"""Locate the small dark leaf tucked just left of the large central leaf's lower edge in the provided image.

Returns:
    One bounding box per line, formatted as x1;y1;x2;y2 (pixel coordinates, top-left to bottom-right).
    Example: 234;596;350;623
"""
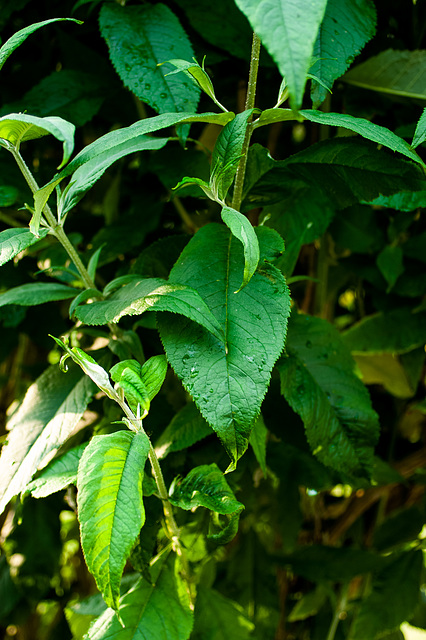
155;402;213;460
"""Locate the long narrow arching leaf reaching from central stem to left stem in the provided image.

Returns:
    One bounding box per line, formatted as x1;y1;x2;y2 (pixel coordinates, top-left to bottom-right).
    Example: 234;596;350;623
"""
34;113;234;220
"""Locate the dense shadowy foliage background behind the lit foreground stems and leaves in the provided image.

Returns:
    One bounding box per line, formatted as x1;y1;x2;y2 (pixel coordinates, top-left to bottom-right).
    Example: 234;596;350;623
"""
0;0;426;640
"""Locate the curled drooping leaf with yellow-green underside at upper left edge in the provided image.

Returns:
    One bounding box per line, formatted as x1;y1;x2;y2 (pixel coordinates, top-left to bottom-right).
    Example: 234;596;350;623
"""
0;113;75;169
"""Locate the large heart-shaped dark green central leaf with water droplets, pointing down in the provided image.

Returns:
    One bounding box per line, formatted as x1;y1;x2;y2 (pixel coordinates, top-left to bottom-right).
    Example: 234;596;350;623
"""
158;224;290;464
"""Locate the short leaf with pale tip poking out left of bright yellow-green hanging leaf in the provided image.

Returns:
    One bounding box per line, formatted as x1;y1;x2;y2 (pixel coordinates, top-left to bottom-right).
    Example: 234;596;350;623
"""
25;442;87;498
